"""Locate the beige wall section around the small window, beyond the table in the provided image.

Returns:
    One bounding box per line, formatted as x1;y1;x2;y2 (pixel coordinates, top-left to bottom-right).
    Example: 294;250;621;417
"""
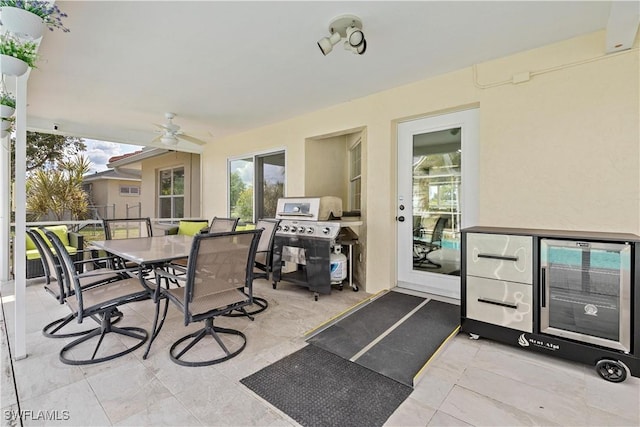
141;152;200;218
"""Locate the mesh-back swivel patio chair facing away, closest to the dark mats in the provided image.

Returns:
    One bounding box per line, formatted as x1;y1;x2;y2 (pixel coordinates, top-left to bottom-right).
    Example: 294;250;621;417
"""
143;230;262;366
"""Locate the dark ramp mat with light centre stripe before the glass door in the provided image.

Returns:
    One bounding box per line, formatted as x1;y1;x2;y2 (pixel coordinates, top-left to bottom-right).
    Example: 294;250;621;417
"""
308;292;460;387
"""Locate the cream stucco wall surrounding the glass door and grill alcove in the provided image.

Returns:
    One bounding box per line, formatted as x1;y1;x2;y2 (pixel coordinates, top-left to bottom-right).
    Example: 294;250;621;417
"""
202;32;640;292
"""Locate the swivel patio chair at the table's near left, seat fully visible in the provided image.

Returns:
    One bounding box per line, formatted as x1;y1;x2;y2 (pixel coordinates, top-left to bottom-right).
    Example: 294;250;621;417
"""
46;231;151;365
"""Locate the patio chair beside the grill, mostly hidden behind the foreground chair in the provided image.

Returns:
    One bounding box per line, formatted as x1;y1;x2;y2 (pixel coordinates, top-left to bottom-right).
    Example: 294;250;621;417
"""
227;218;280;318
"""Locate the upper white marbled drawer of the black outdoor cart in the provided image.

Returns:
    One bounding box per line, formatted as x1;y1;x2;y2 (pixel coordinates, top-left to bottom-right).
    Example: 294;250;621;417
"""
466;233;533;283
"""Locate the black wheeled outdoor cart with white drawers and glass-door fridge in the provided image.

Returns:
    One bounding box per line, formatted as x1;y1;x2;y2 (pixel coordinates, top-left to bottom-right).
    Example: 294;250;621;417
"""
461;227;640;382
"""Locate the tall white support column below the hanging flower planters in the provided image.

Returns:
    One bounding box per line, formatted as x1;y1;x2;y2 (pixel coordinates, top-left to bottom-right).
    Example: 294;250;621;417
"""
13;73;28;360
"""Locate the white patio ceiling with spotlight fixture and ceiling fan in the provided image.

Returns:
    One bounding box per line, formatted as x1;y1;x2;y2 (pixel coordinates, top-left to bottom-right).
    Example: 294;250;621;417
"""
10;1;636;151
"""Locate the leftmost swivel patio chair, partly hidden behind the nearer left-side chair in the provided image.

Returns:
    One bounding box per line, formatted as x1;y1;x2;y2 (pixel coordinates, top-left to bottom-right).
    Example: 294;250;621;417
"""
27;229;126;338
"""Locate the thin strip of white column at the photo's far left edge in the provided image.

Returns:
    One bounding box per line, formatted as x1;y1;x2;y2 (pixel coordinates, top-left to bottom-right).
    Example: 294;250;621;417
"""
0;123;11;284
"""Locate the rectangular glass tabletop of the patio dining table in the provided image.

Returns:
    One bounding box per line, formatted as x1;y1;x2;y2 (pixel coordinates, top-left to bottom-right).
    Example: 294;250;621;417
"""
91;235;193;265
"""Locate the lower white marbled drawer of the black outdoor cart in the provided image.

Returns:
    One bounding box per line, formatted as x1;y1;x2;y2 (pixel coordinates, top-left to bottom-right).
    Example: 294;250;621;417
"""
466;276;533;332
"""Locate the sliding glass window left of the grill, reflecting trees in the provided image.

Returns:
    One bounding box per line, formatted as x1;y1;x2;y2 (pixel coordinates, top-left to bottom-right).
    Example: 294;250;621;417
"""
229;151;285;222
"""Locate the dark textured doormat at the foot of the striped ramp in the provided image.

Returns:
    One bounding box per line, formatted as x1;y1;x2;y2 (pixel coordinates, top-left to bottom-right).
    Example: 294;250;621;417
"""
240;345;412;427
